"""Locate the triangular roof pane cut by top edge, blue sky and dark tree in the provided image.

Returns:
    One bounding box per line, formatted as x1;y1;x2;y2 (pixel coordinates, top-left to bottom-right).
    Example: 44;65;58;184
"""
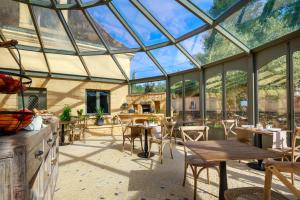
191;0;238;19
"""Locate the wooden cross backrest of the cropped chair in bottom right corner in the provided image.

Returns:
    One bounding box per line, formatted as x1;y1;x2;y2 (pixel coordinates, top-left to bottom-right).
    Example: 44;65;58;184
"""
264;161;300;200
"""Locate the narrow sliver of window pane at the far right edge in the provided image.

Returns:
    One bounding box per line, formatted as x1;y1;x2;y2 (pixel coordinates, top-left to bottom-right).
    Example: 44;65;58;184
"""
293;51;300;127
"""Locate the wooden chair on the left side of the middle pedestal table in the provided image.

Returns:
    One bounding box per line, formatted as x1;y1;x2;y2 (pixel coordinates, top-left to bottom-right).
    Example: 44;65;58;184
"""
118;118;143;155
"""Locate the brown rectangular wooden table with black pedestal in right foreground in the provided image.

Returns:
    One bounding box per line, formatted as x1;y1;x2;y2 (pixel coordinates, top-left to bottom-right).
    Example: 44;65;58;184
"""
185;140;278;199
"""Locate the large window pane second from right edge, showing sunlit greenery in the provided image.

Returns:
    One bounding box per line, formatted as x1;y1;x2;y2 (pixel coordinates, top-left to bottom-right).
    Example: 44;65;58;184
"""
258;56;287;129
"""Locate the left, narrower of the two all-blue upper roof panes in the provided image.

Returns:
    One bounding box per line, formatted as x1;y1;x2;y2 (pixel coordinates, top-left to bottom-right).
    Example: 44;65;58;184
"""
112;0;168;46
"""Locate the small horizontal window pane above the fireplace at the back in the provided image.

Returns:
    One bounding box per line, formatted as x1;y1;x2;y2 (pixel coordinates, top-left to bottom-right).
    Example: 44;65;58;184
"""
131;81;166;93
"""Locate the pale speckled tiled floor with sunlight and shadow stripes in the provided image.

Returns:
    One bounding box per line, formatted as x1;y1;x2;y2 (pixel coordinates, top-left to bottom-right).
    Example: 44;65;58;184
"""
55;136;300;200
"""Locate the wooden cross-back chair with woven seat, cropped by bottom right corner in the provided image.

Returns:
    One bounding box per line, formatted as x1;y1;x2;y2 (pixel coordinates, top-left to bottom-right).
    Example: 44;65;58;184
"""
224;161;300;200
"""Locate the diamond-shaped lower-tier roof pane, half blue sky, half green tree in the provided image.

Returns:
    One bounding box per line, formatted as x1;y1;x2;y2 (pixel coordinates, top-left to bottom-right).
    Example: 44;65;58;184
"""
180;29;242;64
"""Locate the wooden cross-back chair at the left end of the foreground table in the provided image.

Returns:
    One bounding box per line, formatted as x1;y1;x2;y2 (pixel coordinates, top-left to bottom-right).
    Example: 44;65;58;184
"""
180;126;219;200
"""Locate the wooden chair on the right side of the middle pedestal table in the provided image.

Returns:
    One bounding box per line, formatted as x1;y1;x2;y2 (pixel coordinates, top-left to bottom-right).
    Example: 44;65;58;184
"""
149;120;175;164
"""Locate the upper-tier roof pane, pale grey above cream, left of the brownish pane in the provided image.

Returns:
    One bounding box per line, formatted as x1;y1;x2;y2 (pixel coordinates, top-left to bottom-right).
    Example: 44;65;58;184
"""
32;6;74;51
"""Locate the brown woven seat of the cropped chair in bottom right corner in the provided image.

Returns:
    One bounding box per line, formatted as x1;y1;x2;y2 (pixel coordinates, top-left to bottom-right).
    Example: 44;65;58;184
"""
224;187;288;200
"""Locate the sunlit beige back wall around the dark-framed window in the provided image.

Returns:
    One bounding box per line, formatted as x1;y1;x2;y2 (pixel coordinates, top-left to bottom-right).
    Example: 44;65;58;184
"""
0;78;128;115
